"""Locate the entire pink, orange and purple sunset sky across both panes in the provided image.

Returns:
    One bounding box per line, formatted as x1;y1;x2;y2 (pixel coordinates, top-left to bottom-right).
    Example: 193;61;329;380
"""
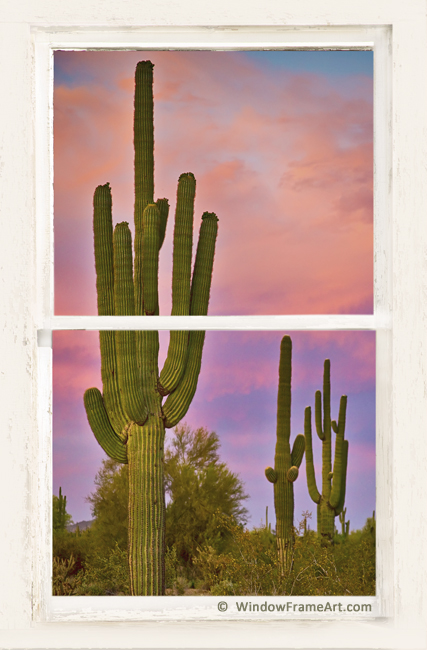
53;51;375;528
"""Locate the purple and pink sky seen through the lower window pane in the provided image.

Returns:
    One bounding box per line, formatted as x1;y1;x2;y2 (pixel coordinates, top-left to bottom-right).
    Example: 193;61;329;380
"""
53;332;375;527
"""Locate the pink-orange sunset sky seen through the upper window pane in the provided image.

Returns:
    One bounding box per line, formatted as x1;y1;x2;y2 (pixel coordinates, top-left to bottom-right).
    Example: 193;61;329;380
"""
54;51;373;315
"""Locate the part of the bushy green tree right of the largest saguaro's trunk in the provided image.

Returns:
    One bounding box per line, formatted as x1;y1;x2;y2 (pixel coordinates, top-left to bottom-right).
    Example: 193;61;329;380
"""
165;424;248;565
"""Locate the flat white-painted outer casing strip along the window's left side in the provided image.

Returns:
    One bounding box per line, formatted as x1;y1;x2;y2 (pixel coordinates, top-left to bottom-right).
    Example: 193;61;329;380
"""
0;23;36;632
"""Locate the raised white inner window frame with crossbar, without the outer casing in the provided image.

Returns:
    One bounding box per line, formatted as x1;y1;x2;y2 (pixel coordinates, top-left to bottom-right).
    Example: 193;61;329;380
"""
34;27;394;626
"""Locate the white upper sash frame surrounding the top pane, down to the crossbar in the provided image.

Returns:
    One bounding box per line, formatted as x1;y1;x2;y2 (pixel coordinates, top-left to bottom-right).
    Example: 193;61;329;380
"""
36;27;392;330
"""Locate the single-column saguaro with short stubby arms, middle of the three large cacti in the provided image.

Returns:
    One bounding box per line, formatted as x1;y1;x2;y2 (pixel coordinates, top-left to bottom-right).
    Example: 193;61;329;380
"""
265;336;305;573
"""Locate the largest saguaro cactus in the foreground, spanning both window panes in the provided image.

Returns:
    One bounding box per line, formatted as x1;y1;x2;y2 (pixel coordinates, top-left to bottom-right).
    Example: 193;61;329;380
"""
84;61;218;595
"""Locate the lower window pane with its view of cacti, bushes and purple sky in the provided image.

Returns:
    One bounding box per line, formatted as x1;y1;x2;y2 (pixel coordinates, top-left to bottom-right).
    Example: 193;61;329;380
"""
53;331;375;595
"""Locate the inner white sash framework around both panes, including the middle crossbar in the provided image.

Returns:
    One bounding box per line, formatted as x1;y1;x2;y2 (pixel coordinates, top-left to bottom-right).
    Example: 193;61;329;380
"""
36;21;393;621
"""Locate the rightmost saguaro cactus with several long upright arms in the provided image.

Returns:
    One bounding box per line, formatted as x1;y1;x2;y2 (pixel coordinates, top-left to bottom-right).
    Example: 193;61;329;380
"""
304;359;348;546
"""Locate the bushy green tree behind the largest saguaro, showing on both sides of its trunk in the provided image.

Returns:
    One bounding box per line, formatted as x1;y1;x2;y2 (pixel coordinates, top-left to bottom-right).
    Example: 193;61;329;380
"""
87;425;248;564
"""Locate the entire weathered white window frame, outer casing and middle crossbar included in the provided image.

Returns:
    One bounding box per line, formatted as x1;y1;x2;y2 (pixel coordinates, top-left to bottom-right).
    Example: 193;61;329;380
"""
0;5;427;648
